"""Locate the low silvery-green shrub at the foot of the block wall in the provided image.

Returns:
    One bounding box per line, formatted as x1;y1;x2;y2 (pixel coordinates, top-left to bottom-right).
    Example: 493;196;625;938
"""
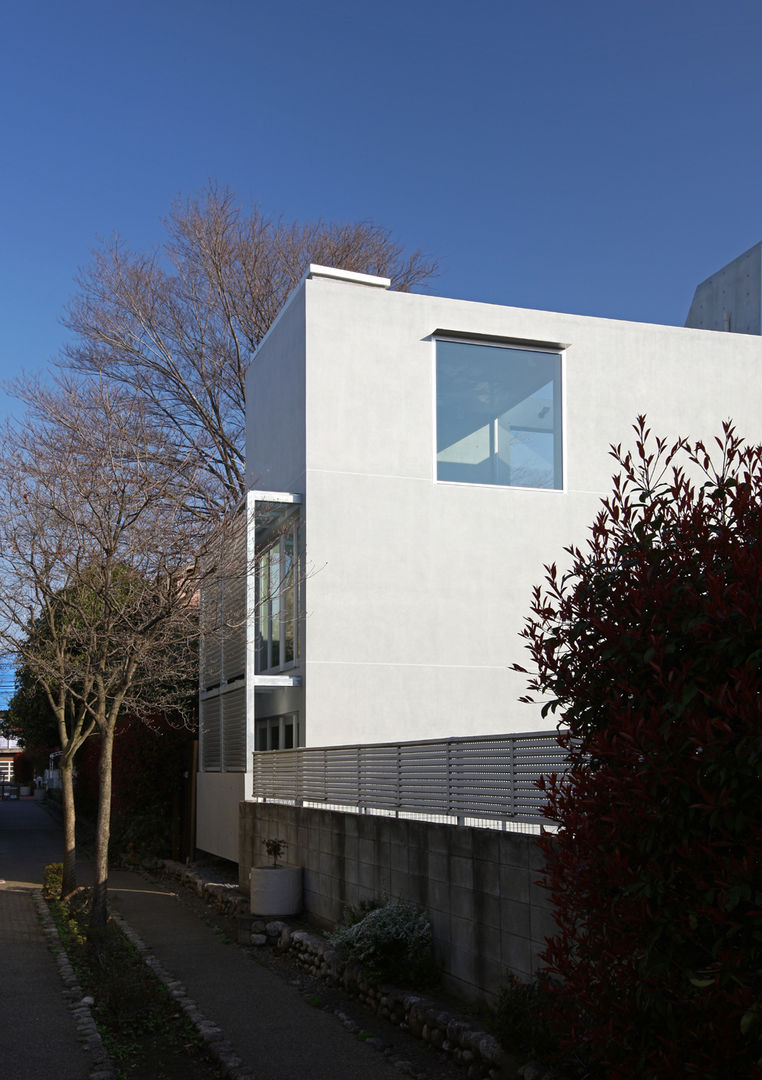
328;901;436;986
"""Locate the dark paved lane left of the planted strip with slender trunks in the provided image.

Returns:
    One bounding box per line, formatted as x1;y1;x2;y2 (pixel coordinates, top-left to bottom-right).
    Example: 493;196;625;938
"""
0;799;95;1080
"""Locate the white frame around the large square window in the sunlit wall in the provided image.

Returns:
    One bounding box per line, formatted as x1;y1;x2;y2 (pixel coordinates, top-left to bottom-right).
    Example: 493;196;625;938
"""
432;329;569;494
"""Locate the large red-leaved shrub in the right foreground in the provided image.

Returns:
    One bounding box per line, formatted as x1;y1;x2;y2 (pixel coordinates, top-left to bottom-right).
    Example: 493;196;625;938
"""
518;417;762;1080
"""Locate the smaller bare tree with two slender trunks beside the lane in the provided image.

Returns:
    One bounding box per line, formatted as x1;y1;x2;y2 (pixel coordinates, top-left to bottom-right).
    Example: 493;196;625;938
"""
0;380;205;924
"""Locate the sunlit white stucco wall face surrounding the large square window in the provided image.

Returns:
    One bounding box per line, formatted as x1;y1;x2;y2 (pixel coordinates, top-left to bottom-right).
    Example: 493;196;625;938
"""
293;272;762;745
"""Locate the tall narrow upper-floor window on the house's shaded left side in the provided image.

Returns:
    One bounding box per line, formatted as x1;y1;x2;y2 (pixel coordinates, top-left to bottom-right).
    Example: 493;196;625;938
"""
256;524;299;675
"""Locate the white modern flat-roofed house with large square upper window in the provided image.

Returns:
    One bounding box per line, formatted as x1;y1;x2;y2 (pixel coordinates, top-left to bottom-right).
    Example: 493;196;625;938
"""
198;245;762;860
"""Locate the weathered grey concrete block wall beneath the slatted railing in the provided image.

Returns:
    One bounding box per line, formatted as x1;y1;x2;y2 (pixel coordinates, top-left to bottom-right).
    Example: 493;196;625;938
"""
240;802;555;998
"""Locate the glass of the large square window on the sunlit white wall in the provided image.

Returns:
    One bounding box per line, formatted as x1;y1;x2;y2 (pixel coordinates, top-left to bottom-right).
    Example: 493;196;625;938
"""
436;340;562;488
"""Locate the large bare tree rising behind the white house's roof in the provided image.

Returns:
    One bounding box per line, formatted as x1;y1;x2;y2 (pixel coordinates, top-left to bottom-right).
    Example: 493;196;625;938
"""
65;186;436;518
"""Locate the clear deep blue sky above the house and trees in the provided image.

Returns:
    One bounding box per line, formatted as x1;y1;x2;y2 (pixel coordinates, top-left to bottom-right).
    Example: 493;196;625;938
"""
0;0;762;704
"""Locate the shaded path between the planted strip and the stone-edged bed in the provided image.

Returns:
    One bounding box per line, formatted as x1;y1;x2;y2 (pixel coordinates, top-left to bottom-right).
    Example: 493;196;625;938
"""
103;870;442;1080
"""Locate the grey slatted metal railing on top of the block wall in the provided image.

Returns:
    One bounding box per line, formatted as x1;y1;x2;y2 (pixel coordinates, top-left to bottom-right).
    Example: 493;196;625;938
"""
251;731;566;828
